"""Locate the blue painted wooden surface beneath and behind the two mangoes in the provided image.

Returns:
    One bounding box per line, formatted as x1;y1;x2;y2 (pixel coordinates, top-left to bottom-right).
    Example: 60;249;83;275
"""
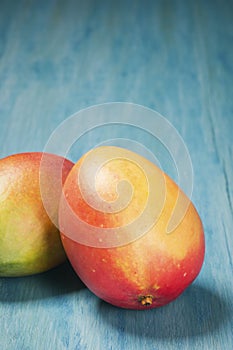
0;0;233;350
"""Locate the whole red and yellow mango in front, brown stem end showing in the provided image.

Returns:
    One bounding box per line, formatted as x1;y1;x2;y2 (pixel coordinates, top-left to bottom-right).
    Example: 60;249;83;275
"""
59;146;205;310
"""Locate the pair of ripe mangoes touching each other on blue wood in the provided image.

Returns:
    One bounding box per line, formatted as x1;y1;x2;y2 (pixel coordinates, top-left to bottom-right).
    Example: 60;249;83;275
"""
0;147;204;309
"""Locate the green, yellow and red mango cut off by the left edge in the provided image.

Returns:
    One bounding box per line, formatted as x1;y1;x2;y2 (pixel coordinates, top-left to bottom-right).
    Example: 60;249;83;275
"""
0;152;73;277
